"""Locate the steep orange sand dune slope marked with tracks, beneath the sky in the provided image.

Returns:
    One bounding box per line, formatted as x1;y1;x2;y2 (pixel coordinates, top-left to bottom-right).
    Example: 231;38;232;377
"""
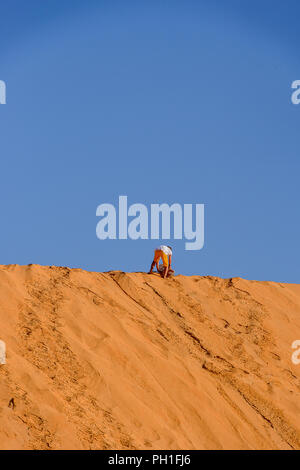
0;265;300;449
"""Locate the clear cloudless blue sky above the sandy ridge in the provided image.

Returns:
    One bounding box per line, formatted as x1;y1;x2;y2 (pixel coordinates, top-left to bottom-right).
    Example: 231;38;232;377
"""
0;0;300;283
